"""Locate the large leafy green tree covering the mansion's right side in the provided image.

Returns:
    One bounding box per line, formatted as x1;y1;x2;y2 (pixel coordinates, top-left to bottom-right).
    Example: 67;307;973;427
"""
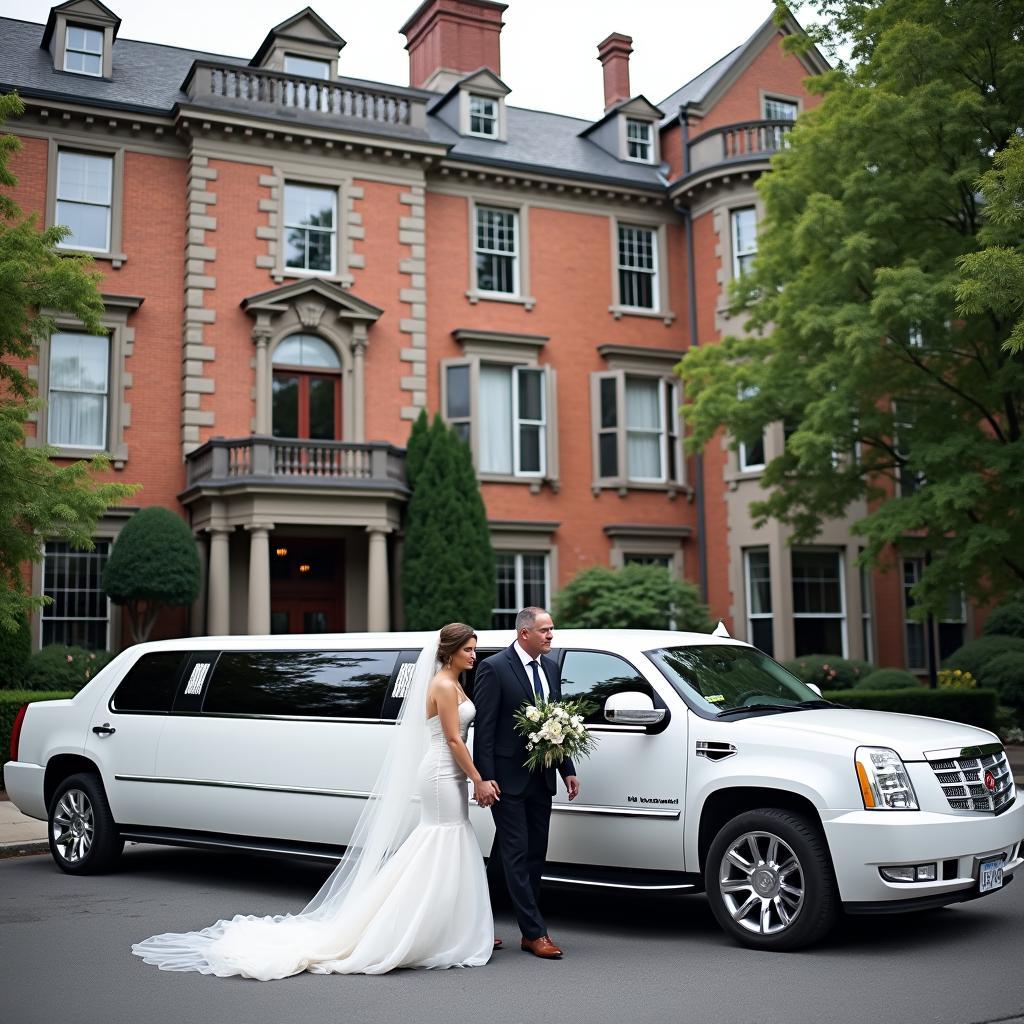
681;0;1024;614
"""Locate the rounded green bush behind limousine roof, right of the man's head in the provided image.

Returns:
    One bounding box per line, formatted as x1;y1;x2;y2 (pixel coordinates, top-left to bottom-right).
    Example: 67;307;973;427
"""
554;565;714;633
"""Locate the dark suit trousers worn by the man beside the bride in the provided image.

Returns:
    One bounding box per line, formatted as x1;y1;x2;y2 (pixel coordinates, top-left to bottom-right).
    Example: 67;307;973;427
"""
490;773;551;939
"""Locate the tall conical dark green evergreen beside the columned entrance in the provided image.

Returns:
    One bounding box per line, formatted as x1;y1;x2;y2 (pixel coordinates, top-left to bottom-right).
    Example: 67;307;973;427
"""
401;416;495;630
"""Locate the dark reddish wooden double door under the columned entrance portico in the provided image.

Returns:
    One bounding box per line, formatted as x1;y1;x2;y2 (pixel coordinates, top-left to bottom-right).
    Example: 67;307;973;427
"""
270;536;345;633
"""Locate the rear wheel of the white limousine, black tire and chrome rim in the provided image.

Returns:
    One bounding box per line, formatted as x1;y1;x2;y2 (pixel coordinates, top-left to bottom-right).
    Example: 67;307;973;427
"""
47;772;125;874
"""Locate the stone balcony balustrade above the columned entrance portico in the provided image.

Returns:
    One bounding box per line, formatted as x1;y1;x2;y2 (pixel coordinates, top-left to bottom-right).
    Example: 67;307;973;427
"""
185;436;406;489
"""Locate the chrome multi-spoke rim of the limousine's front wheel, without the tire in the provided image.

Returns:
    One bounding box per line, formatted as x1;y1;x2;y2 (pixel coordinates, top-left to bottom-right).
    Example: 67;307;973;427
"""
718;831;805;935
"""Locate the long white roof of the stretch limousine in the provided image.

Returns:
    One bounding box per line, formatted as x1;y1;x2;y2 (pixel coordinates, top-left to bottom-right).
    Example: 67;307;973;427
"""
121;628;749;653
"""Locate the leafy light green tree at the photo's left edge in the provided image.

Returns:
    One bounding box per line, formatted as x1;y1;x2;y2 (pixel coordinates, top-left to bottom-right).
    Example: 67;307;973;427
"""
0;93;138;632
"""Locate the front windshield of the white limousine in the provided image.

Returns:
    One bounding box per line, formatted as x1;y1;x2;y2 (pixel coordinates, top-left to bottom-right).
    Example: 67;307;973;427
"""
647;644;825;715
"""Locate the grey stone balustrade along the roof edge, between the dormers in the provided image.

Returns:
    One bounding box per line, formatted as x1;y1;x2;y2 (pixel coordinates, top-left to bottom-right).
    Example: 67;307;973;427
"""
182;60;427;130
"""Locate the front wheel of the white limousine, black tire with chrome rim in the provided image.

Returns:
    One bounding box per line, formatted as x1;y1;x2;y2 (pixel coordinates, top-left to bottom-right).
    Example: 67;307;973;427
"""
705;807;840;951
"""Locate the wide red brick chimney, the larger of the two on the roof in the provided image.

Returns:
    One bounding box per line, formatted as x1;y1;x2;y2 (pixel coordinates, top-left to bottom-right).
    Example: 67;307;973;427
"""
399;0;508;92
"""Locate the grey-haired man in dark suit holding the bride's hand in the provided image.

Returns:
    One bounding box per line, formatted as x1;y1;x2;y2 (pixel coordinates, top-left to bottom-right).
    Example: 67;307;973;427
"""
473;607;580;959
